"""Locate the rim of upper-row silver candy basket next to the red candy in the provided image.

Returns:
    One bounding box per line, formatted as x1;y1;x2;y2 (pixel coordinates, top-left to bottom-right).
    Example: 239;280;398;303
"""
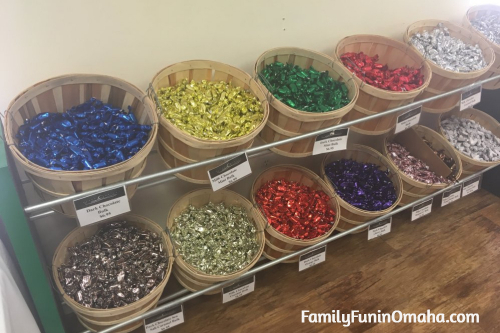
403;19;495;79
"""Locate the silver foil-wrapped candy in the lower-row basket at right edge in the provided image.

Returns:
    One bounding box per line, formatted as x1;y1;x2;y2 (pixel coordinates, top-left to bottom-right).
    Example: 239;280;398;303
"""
441;116;500;162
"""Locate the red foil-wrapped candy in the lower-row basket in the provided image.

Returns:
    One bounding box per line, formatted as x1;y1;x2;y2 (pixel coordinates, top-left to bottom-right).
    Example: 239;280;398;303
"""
255;179;335;240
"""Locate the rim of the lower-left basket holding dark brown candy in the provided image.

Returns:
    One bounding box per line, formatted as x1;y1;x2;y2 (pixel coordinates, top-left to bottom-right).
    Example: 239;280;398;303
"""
52;213;174;316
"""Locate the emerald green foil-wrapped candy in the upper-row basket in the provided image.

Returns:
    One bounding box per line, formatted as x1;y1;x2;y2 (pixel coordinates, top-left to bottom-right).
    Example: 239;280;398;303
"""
259;62;350;112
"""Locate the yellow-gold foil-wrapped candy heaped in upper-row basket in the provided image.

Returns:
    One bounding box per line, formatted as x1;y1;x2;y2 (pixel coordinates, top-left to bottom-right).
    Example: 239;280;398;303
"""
157;79;264;140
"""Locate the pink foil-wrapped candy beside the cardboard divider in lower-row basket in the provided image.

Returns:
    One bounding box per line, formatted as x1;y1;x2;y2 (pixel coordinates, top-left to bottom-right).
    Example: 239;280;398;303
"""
387;142;449;184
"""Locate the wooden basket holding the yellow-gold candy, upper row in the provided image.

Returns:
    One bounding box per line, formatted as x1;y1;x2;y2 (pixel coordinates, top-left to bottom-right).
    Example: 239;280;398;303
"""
152;60;269;184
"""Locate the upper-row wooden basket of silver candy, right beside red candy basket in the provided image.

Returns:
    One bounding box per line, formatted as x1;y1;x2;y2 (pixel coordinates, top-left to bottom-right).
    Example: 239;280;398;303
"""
403;20;495;113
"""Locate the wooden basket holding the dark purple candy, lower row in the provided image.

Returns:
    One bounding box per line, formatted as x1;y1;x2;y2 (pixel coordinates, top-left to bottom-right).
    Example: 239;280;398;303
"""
321;145;403;224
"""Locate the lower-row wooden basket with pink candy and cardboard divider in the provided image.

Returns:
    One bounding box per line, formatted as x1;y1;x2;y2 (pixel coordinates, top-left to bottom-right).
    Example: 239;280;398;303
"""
382;125;462;204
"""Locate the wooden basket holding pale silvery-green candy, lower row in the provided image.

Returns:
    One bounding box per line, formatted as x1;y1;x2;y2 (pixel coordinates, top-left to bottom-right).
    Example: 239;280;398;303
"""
166;188;265;294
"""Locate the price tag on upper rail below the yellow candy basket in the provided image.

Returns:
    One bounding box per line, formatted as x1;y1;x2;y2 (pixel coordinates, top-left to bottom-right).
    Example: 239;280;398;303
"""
208;153;252;192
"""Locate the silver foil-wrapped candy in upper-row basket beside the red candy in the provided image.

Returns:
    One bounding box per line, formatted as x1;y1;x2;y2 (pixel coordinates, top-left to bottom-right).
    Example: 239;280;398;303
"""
410;23;487;73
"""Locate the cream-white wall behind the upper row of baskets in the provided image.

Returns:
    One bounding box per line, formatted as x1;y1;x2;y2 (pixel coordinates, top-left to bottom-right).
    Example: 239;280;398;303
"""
0;0;500;111
